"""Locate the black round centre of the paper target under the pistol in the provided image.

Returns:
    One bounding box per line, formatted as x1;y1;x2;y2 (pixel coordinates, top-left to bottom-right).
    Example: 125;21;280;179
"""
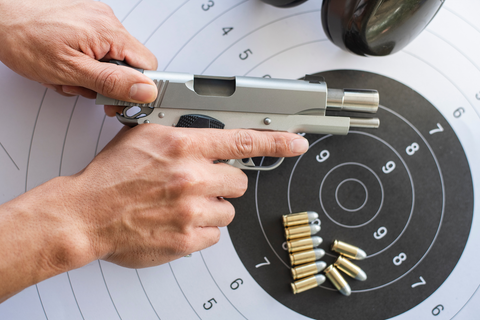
228;70;473;319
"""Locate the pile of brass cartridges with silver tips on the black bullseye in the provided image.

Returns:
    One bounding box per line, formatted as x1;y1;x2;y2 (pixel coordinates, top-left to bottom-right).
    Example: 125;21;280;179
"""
282;211;367;296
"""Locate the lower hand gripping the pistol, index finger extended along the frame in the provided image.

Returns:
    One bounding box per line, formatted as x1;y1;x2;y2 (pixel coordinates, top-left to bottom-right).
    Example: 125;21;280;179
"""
66;124;308;268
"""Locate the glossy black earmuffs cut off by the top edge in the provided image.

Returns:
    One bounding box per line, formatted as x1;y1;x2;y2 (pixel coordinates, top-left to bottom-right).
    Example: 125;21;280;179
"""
262;0;444;56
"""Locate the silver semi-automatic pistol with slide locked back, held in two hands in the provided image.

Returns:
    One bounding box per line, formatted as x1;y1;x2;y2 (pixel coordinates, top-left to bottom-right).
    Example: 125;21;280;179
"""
96;61;380;170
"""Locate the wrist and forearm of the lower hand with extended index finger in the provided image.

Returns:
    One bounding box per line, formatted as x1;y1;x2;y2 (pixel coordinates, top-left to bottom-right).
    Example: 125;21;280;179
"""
0;177;95;302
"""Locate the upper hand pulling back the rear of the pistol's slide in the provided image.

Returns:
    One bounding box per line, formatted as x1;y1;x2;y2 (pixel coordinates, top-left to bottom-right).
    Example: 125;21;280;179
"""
0;0;157;102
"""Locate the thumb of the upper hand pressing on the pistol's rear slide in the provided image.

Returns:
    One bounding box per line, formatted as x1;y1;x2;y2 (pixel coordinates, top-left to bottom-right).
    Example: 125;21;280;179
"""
76;57;157;103
